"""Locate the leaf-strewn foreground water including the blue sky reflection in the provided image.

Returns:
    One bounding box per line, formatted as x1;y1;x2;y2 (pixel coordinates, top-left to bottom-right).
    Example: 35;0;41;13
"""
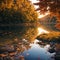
0;39;60;60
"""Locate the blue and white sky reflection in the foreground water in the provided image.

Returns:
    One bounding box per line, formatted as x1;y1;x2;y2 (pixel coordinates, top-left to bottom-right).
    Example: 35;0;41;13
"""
22;40;55;60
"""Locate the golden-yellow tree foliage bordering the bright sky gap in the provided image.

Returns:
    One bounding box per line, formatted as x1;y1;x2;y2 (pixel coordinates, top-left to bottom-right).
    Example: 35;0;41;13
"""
16;0;38;22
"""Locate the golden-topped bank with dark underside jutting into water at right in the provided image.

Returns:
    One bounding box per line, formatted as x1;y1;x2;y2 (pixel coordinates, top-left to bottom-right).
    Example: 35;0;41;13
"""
37;32;60;43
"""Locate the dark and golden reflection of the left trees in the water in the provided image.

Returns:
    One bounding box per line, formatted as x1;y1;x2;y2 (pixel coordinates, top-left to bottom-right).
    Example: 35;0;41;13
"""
0;26;38;43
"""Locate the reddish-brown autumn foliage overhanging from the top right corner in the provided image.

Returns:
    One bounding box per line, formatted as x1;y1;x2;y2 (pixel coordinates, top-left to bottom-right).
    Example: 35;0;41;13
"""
34;0;60;29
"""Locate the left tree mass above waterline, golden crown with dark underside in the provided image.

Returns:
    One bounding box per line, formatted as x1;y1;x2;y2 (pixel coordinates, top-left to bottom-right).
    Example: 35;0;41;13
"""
0;0;38;23
